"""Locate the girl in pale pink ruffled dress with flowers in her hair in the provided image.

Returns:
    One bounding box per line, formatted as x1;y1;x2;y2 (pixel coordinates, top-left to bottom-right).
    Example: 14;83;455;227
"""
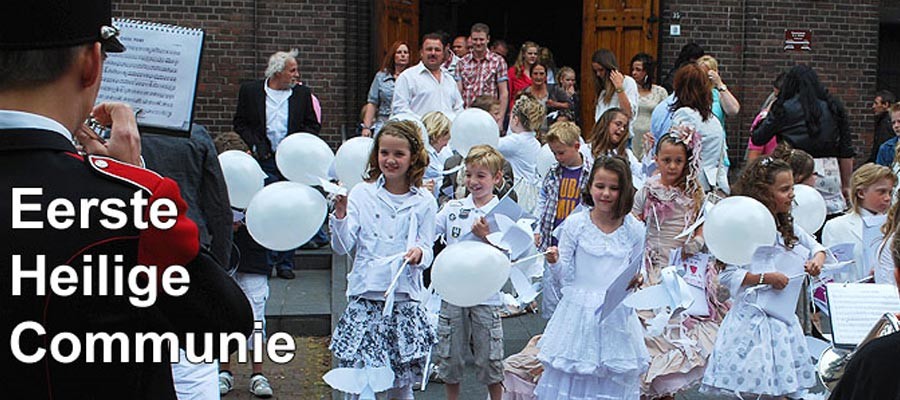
632;126;727;399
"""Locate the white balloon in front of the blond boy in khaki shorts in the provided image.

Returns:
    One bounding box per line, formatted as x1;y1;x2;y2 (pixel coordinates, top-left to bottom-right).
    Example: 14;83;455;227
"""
431;241;510;307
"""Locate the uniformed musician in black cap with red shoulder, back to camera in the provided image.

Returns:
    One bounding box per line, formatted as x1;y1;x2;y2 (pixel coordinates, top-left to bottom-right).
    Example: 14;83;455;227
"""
0;0;252;399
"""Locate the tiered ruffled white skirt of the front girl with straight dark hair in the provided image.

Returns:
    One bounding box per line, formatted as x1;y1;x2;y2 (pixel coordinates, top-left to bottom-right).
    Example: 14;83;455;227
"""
535;287;650;400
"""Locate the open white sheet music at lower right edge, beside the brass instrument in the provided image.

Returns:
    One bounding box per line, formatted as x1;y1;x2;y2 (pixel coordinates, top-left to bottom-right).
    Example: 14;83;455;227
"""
825;283;900;348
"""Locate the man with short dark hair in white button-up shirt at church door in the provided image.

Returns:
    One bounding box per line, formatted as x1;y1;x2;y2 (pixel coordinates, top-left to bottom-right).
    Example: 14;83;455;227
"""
391;33;463;120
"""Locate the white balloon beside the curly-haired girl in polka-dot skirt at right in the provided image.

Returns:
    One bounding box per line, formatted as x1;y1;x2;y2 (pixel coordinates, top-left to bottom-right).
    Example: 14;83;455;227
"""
703;196;775;265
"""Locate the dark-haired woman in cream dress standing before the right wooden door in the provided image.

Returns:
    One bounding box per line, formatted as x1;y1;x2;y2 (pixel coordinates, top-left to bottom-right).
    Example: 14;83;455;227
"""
631;53;669;156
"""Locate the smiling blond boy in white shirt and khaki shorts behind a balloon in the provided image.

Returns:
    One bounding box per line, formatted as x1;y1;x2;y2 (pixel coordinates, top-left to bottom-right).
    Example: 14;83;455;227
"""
435;145;504;400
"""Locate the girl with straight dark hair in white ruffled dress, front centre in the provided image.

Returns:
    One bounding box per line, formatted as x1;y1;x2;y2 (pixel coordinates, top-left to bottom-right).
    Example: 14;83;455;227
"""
535;156;649;400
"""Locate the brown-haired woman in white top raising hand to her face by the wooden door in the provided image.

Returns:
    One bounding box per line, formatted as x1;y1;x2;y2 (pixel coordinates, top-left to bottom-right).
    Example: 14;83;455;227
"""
591;49;638;124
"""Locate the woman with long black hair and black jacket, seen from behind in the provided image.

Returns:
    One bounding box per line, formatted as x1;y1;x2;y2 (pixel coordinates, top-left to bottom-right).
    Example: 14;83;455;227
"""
751;64;855;216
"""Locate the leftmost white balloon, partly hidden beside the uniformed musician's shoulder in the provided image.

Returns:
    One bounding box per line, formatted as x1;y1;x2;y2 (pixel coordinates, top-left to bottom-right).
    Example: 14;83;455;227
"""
219;150;266;209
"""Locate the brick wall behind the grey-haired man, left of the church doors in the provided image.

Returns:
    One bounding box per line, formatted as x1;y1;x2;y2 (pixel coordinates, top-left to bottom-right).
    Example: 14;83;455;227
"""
113;0;371;146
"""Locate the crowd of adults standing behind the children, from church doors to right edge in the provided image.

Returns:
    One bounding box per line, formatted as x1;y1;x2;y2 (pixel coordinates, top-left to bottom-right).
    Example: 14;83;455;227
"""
357;23;897;215
